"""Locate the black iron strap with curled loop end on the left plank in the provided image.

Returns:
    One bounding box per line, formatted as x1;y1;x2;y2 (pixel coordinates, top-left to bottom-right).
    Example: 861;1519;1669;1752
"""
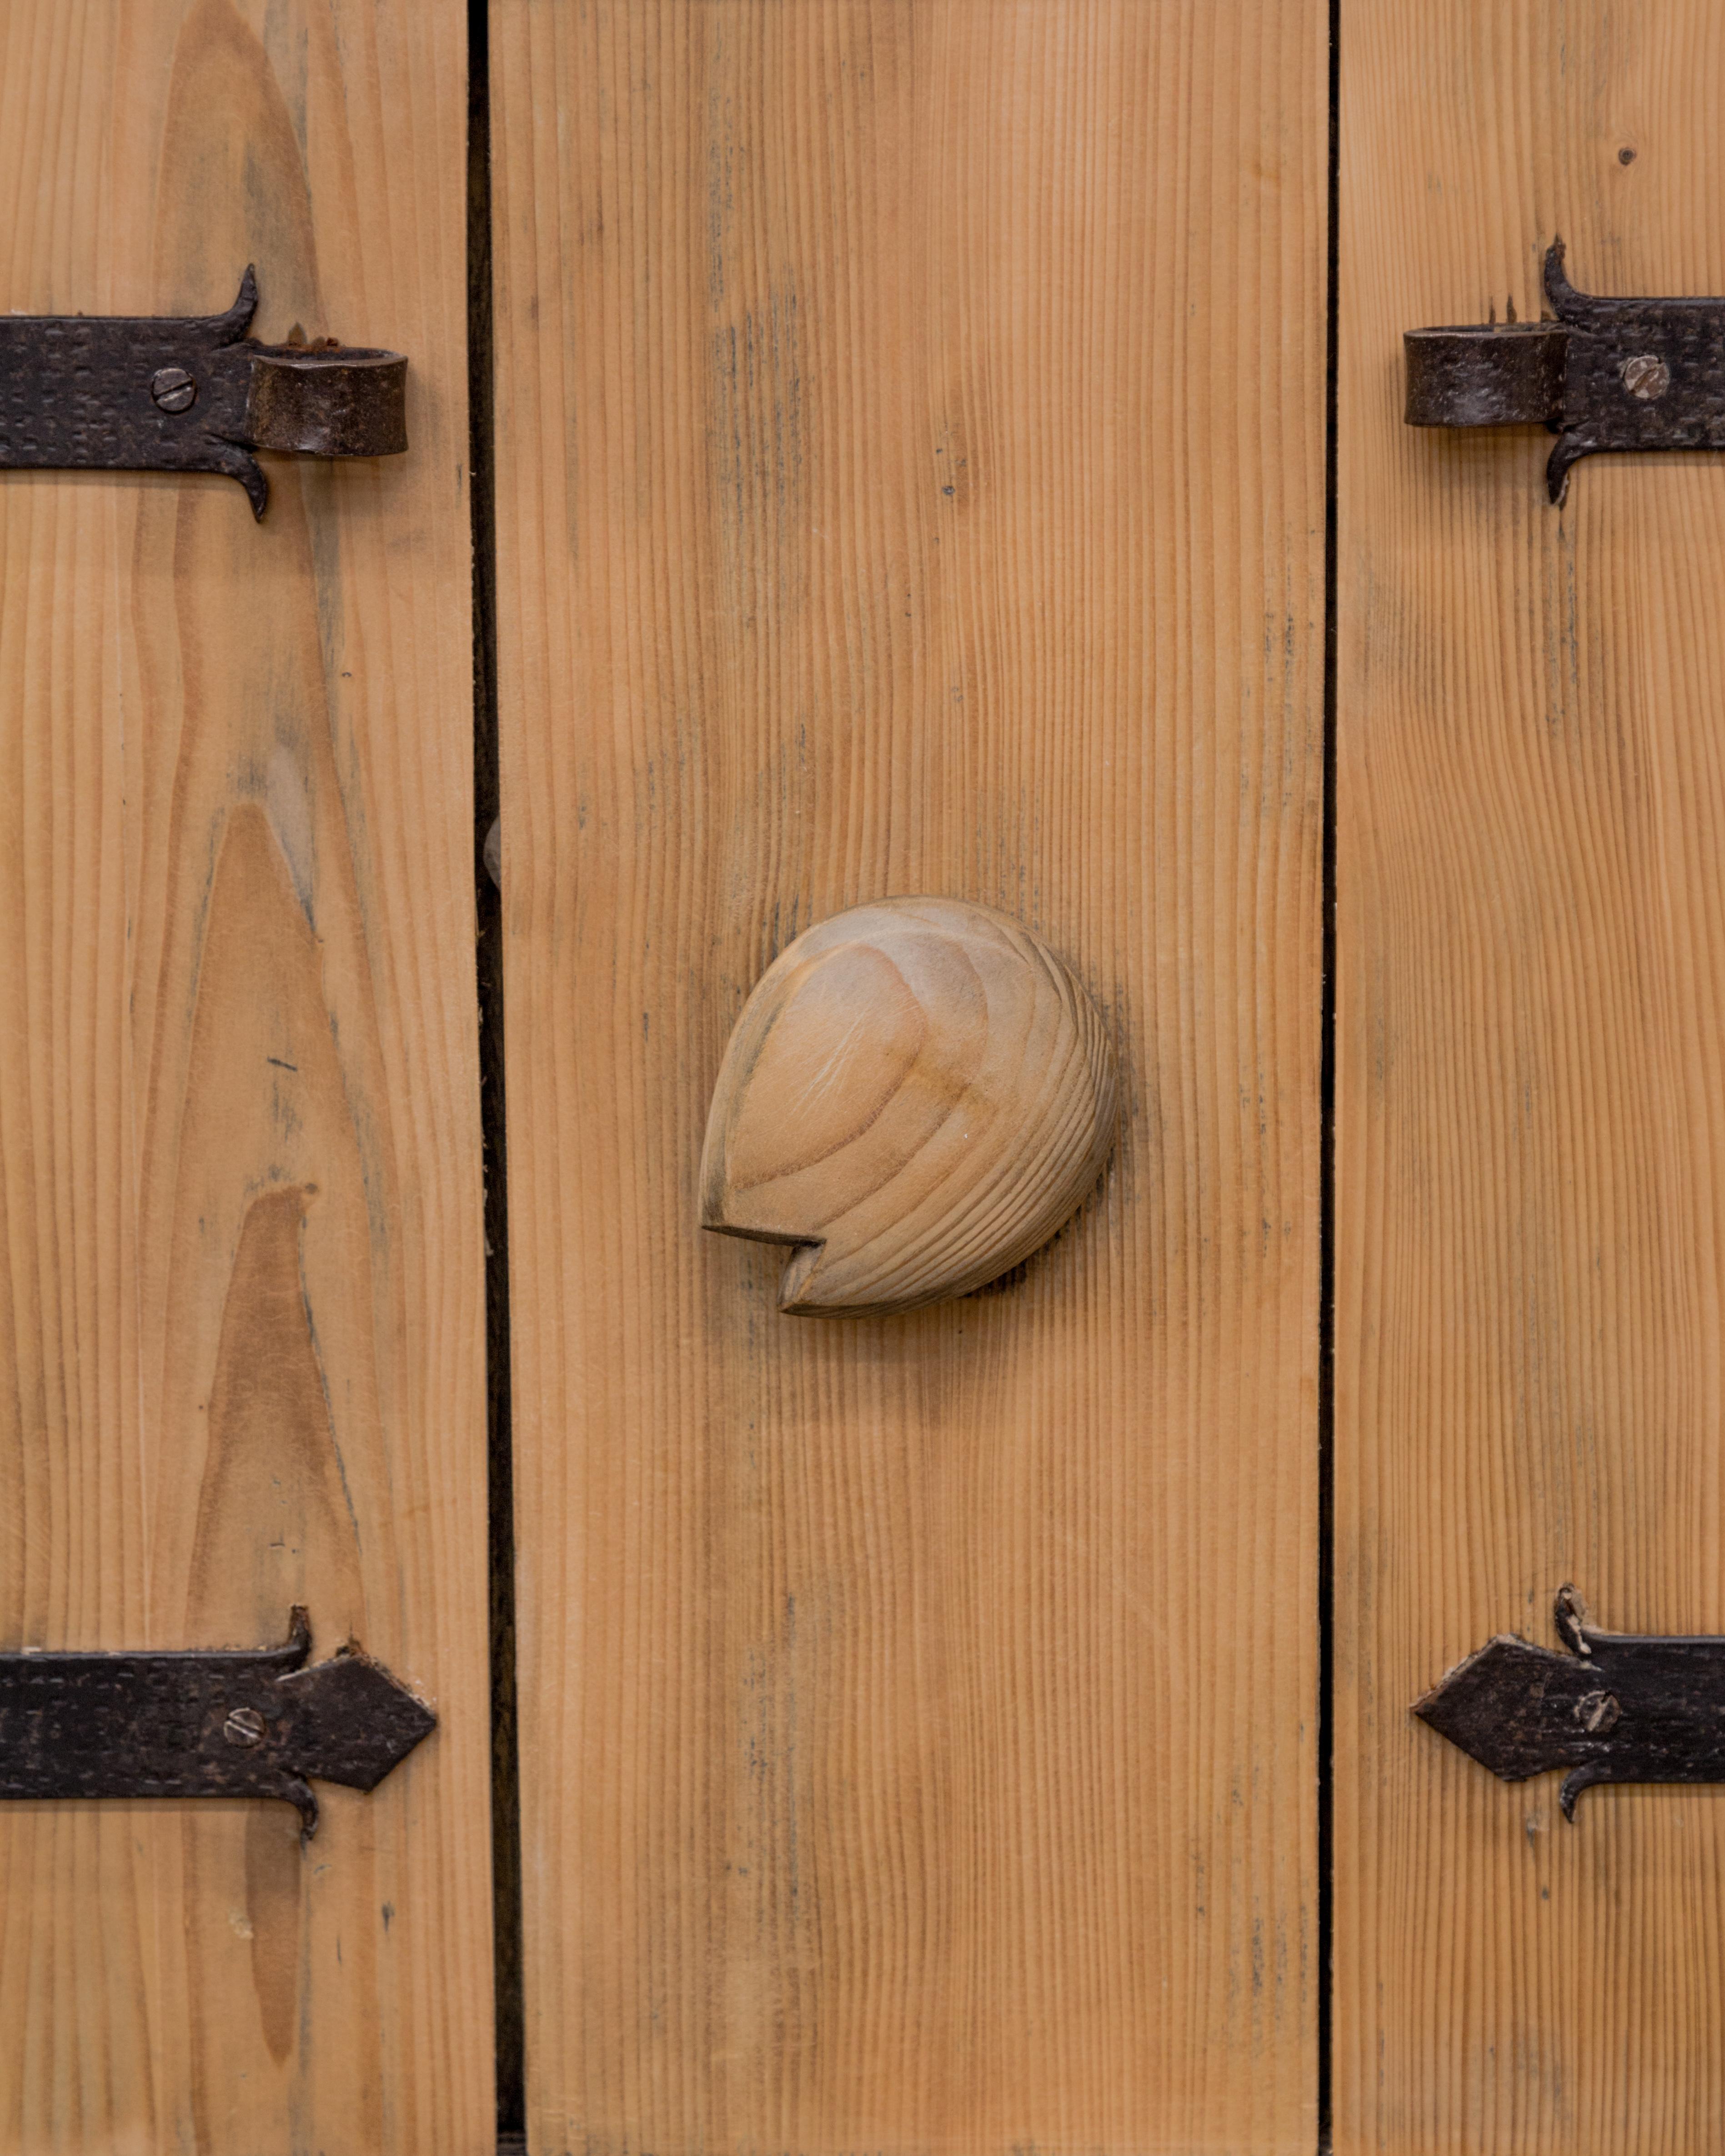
0;270;407;517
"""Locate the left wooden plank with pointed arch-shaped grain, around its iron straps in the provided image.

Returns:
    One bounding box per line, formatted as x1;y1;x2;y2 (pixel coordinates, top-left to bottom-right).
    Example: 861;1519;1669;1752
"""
0;0;494;2156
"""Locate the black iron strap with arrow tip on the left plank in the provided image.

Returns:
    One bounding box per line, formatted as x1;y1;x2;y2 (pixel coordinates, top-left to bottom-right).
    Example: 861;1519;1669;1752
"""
0;1609;438;1839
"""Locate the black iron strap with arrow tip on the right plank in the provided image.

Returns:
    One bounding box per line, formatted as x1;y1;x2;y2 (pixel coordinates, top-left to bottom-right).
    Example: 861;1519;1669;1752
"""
1412;1587;1725;1820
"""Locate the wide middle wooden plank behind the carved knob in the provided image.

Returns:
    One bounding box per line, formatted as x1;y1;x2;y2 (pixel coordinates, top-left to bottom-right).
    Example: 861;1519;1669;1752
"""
491;0;1326;2156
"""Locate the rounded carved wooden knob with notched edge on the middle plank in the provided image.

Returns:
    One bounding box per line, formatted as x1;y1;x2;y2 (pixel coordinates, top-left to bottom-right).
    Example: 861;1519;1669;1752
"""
701;899;1117;1317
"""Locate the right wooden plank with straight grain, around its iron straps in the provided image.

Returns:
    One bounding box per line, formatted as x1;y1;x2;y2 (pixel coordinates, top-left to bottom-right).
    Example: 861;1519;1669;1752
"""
1335;0;1725;2156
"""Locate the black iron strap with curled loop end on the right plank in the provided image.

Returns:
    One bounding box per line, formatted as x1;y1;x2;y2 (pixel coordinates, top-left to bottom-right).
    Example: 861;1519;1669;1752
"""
1402;239;1725;502
